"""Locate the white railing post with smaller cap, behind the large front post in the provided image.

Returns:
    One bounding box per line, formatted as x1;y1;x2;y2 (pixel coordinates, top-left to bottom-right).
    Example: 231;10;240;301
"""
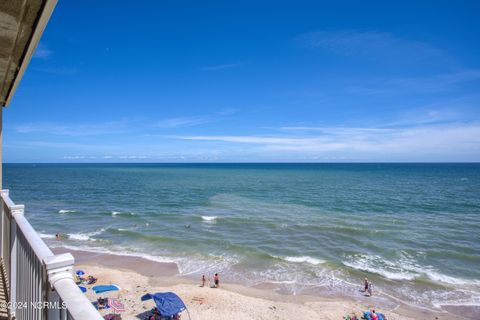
9;204;25;318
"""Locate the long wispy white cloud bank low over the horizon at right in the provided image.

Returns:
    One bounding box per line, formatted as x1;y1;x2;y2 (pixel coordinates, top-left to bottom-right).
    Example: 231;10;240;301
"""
178;122;480;161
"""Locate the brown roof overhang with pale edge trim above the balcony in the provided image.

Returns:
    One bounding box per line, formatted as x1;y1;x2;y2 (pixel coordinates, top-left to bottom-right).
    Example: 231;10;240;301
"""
0;0;57;107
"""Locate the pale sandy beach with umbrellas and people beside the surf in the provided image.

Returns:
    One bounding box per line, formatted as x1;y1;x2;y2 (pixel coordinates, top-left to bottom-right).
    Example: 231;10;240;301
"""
55;248;464;320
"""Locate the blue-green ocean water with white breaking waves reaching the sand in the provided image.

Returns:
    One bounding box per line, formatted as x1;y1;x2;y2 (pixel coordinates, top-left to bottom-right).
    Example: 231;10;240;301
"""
4;164;480;308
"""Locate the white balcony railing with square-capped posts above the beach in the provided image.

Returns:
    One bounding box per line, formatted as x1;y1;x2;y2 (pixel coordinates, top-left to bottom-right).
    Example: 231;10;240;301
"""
0;190;103;320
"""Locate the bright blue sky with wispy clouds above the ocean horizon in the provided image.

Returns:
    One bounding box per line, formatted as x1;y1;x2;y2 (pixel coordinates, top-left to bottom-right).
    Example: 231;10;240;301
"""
3;0;480;162
